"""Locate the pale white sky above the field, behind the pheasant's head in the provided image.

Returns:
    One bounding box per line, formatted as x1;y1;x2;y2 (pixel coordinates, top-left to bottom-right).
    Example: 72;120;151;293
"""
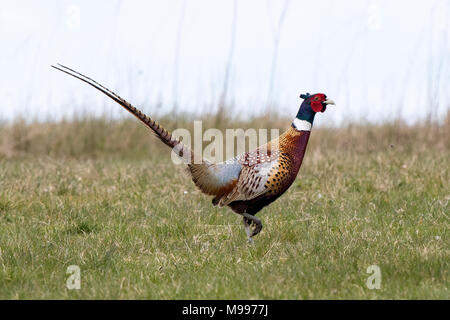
0;0;450;124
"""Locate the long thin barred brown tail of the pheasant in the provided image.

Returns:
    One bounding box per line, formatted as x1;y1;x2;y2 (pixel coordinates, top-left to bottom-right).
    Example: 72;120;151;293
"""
52;63;193;160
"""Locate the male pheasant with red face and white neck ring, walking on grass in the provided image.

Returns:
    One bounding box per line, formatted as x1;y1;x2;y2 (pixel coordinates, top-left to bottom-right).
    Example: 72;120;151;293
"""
52;64;334;242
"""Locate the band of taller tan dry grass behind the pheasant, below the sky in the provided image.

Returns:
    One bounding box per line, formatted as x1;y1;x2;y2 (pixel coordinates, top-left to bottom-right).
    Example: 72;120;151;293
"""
0;113;450;158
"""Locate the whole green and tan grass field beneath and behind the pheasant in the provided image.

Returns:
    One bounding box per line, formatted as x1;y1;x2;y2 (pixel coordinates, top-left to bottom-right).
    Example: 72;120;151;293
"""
0;117;450;299
